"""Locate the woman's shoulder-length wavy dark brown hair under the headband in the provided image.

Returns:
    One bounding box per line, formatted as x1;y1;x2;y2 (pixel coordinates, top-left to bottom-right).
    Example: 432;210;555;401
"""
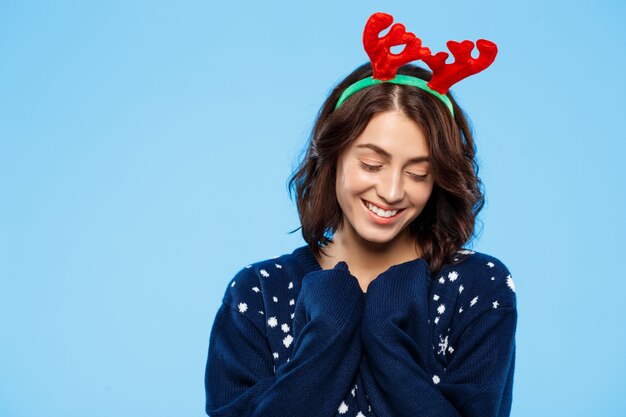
288;63;485;276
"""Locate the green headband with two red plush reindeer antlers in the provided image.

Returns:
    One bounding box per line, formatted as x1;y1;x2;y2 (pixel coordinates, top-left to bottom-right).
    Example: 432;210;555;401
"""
335;12;498;116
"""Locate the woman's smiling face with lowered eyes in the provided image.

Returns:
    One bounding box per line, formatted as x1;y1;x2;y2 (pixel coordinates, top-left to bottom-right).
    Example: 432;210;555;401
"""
336;111;434;243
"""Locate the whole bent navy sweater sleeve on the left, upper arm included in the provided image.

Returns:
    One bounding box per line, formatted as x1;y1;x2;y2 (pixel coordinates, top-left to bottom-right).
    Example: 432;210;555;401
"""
205;263;364;417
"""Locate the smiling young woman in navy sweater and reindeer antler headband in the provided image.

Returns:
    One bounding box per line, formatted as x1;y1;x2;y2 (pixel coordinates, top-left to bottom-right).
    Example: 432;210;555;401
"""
205;13;517;417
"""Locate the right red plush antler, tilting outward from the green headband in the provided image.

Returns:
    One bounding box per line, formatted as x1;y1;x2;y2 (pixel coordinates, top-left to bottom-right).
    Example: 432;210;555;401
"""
422;39;498;94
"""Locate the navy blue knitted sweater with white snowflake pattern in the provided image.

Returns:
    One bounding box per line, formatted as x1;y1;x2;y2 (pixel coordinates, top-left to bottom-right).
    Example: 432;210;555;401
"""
205;246;517;417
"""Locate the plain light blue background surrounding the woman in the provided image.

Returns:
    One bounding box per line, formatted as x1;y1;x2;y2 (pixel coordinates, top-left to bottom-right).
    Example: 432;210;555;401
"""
0;0;626;417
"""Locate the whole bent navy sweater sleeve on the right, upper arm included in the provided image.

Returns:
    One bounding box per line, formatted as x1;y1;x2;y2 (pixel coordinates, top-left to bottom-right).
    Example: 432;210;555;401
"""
361;259;516;417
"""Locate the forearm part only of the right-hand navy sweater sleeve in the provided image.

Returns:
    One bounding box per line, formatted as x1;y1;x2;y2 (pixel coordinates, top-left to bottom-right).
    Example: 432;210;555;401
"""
361;259;461;417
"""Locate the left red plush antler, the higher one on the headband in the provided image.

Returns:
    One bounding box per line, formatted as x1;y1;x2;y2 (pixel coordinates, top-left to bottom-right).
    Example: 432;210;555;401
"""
363;12;428;81
